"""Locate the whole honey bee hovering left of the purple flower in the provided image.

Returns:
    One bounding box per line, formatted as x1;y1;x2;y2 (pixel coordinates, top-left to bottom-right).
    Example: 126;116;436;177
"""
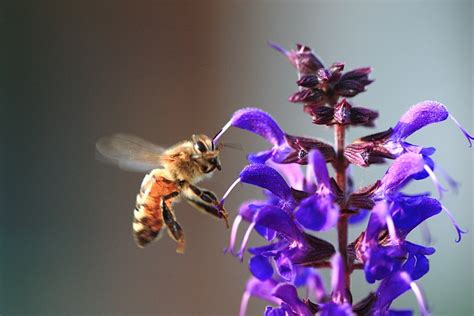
96;134;229;253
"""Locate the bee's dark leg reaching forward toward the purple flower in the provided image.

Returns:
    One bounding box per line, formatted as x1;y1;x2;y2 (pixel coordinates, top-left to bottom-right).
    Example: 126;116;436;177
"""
183;184;229;228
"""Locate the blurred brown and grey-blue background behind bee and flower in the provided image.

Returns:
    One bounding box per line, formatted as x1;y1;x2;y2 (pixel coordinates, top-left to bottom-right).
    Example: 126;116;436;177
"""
0;0;474;315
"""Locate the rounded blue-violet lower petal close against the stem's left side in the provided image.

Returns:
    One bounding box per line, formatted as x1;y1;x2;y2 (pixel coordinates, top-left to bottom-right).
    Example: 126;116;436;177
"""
295;194;339;231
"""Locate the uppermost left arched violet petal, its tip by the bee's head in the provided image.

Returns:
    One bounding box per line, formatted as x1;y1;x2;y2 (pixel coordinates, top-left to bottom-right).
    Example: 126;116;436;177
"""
231;108;285;146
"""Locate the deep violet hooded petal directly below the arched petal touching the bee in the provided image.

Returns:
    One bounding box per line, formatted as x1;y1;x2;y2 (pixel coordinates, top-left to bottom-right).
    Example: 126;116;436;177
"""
240;164;292;201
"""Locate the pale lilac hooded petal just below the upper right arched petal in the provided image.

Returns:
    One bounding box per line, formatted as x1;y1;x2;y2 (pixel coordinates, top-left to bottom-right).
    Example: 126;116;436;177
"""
380;153;425;194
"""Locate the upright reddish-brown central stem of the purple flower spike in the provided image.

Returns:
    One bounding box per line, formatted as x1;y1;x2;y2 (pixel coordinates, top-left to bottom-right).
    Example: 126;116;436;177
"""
334;124;351;293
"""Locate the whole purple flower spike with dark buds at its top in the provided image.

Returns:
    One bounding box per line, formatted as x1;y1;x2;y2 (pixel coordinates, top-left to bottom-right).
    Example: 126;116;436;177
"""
214;44;473;316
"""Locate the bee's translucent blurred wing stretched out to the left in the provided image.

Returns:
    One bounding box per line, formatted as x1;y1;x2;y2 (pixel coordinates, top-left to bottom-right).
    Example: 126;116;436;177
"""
96;134;165;172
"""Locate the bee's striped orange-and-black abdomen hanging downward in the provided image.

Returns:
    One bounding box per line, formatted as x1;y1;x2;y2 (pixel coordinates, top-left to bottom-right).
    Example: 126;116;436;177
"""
133;169;177;247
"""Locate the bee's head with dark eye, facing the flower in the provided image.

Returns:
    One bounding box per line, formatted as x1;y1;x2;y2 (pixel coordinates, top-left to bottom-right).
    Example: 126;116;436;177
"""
192;134;221;173
